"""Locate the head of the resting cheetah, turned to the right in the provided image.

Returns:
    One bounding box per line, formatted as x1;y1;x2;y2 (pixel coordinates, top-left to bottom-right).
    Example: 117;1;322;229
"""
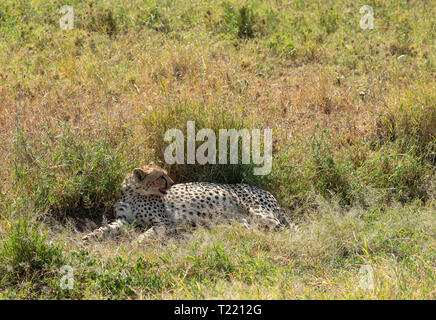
129;164;174;196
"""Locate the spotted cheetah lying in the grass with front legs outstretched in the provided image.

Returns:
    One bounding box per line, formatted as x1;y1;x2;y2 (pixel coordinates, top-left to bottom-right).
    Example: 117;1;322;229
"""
82;164;292;243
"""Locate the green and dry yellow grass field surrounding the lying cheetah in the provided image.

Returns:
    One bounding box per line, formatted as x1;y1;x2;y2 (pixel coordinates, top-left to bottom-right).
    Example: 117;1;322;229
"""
0;0;436;299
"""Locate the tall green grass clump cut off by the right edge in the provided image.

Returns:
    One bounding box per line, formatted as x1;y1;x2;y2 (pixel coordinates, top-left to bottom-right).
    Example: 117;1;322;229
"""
362;85;436;202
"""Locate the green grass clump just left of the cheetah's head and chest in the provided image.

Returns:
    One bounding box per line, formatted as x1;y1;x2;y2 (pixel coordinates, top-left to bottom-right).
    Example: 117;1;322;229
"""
13;124;128;217
